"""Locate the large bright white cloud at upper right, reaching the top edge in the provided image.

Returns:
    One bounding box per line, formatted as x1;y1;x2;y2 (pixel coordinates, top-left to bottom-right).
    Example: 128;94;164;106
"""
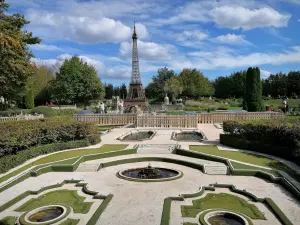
155;0;291;30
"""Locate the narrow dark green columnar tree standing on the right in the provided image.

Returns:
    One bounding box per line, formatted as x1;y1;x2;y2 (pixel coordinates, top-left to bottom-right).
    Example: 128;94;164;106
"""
243;67;263;112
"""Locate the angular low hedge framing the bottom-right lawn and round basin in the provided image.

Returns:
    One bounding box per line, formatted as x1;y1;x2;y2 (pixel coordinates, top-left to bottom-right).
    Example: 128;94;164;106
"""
160;183;293;225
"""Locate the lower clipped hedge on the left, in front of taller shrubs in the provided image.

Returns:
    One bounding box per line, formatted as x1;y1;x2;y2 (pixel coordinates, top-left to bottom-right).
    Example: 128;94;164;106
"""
0;140;90;173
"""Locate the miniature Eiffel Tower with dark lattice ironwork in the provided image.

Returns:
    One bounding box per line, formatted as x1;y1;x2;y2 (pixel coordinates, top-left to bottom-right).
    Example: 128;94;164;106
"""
124;24;150;112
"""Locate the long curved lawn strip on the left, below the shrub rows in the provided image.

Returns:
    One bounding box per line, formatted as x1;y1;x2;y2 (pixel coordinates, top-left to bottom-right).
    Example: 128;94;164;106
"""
0;145;127;183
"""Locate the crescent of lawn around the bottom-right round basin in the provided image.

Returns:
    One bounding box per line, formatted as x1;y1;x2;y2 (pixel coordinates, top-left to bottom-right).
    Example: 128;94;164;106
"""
181;193;265;220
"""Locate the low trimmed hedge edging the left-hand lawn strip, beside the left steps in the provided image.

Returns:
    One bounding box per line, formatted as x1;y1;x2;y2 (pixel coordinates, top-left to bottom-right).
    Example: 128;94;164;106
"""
0;149;137;192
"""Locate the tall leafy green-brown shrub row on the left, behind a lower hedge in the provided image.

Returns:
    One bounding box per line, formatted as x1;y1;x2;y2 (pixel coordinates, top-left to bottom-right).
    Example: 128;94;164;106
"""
0;118;100;156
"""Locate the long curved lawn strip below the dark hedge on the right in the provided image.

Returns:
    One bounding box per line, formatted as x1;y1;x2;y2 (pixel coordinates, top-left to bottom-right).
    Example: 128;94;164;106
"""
189;145;300;181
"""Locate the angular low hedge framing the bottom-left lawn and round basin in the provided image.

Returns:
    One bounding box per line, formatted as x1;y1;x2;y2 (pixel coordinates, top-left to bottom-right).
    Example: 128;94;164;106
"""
0;180;113;225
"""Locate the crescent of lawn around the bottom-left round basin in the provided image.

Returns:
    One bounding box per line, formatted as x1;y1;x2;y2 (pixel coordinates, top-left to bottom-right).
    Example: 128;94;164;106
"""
16;190;93;214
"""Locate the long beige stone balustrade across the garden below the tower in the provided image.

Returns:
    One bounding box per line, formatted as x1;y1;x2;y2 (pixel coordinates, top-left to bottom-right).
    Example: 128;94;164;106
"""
73;112;283;128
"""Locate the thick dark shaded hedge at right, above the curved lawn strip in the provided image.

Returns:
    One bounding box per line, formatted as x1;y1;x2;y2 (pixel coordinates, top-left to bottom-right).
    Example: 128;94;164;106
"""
220;117;300;165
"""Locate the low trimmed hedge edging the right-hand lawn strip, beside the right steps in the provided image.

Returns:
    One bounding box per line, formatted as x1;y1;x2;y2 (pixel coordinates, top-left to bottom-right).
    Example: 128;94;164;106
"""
175;149;300;199
